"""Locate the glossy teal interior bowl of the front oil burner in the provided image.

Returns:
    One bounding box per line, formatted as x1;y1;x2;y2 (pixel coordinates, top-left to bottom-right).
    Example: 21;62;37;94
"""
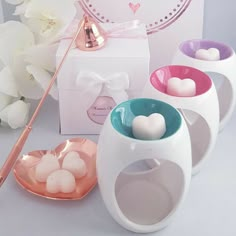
111;98;182;139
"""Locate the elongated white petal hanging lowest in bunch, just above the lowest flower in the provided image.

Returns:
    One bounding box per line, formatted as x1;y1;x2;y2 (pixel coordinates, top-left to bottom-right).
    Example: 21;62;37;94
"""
13;56;44;99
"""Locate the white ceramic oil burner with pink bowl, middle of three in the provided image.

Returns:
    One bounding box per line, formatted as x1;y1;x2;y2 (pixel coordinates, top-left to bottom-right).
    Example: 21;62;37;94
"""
143;66;219;174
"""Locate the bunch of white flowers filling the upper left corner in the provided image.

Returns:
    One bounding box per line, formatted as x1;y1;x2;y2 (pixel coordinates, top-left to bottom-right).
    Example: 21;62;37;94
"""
0;0;76;129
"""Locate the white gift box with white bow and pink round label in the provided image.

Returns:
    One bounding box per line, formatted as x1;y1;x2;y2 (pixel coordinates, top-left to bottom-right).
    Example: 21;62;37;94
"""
57;24;150;134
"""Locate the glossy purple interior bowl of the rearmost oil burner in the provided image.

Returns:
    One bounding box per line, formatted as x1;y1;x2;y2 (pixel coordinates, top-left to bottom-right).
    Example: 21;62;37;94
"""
179;39;234;60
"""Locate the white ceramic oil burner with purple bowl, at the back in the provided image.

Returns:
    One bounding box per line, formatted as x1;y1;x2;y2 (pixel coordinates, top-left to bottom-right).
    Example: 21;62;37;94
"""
173;39;236;131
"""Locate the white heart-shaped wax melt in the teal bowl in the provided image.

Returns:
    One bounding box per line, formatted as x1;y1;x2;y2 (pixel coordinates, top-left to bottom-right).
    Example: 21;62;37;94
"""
132;113;166;140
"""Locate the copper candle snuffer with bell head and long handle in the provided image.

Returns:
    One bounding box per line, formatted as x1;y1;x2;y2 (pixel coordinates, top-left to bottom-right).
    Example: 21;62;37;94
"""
0;15;106;187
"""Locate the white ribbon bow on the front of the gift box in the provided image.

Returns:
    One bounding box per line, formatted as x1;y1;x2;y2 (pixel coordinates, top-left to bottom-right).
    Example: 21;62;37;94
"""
76;71;129;107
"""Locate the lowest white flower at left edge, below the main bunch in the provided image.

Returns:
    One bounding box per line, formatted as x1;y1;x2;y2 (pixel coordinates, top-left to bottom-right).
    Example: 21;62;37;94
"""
0;100;30;129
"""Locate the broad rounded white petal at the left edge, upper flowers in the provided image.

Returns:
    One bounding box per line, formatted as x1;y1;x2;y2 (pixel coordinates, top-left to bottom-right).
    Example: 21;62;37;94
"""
0;21;34;65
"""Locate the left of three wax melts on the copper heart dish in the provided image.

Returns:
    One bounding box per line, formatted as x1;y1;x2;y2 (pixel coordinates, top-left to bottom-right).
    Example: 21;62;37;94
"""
35;154;60;183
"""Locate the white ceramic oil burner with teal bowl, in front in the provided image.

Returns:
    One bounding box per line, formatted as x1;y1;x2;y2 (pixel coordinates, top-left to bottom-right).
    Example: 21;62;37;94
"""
97;99;192;233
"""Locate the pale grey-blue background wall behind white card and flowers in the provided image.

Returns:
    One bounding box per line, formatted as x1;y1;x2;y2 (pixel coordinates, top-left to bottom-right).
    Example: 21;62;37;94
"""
0;0;236;49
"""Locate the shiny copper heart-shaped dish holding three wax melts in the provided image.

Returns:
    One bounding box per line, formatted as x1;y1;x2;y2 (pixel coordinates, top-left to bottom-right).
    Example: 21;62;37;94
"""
14;138;97;200
